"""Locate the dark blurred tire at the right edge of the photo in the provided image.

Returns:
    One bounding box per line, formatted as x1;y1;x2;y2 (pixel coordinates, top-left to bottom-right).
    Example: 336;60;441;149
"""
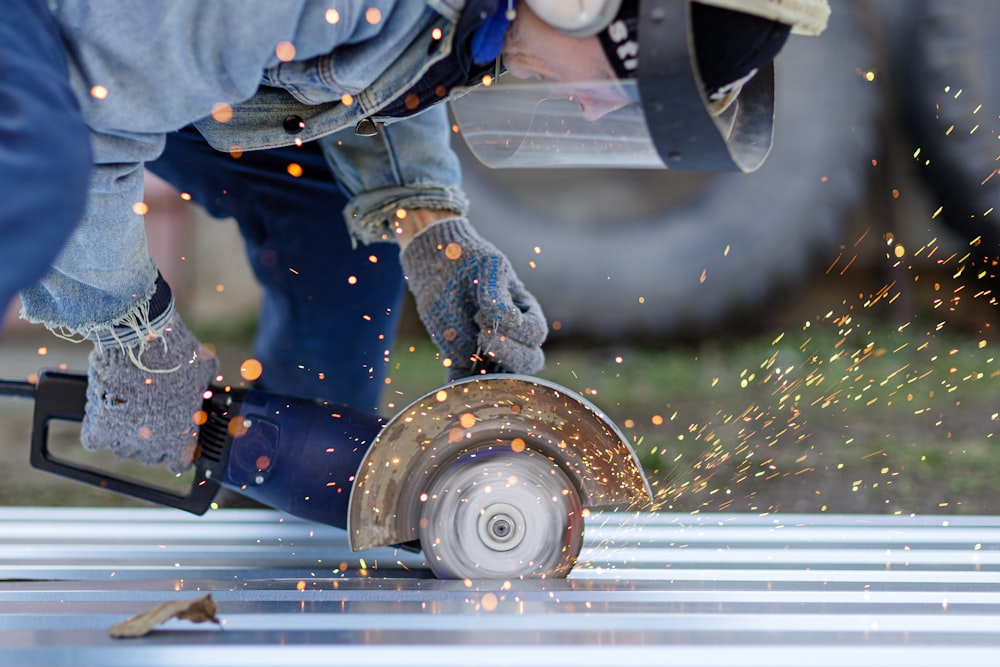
890;0;1000;290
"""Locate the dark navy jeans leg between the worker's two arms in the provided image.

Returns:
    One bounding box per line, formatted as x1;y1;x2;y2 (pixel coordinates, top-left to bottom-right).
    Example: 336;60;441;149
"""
147;128;404;410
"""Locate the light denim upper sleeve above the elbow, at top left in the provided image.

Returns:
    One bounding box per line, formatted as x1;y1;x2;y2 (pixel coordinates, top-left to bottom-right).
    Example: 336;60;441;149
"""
50;0;402;136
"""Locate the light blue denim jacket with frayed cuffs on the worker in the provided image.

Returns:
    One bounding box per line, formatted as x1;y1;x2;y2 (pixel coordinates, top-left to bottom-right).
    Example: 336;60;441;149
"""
22;0;467;338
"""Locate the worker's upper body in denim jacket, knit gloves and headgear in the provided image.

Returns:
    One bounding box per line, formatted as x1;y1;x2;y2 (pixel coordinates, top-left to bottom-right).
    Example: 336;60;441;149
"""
13;0;828;470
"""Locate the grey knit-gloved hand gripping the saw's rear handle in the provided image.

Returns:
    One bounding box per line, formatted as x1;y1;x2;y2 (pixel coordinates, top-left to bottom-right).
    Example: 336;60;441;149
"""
80;314;219;474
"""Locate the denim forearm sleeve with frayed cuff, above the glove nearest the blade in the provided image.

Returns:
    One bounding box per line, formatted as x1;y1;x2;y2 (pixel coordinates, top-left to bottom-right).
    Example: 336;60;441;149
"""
319;105;469;243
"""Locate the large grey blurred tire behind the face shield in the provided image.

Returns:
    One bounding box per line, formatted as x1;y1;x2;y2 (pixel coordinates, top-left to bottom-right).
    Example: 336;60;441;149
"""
456;3;877;340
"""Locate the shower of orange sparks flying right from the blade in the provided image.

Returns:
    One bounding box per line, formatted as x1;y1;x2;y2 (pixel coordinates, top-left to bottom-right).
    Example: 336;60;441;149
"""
622;228;1000;513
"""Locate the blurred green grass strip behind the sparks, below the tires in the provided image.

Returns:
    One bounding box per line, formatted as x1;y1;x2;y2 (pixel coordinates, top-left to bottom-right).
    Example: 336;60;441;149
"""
385;304;1000;514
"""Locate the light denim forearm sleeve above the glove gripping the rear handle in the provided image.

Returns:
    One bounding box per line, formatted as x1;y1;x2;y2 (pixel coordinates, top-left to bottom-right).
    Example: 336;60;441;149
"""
21;133;163;339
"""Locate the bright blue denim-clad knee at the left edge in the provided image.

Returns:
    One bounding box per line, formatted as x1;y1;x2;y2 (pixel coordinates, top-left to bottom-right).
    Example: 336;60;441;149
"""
0;0;91;324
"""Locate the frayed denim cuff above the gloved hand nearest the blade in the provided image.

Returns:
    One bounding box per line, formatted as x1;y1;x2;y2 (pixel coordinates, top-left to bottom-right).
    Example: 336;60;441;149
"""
344;186;469;245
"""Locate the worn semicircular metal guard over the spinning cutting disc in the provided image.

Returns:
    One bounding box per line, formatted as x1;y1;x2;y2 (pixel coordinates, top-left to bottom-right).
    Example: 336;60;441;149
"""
348;374;652;551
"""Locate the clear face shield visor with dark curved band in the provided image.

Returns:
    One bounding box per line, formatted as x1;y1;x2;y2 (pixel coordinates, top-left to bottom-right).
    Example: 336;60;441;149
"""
451;1;774;172
